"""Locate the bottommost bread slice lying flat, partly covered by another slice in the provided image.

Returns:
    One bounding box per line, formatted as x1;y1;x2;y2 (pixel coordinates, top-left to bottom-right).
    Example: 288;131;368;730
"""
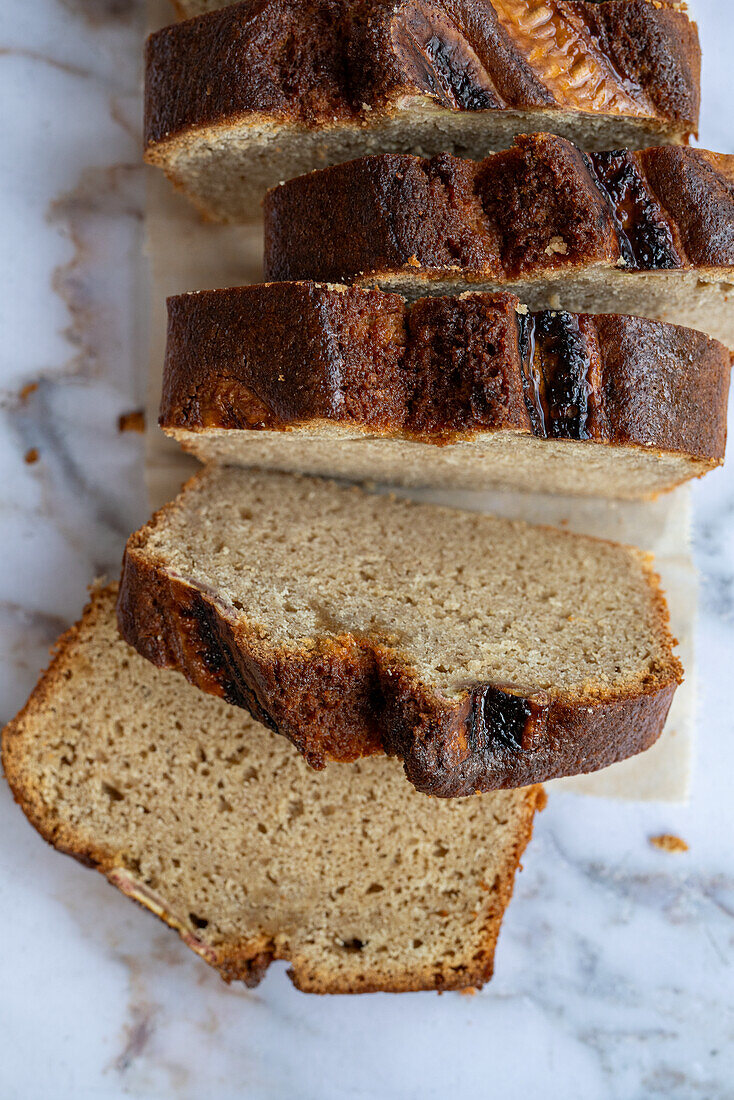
2;589;543;993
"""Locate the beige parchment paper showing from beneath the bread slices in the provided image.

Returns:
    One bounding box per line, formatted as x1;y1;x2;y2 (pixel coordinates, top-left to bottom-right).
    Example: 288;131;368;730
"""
145;0;697;802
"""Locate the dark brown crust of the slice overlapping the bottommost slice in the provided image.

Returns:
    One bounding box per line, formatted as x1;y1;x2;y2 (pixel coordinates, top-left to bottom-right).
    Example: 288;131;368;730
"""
118;486;682;798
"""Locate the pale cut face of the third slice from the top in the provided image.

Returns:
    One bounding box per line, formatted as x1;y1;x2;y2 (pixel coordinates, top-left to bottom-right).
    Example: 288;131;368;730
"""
165;424;723;501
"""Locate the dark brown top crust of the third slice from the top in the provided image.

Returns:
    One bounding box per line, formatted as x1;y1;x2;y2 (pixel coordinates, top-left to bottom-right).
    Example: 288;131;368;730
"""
160;283;731;462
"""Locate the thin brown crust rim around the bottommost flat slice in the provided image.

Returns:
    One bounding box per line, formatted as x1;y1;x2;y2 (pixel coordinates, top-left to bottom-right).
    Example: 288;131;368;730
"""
2;585;546;993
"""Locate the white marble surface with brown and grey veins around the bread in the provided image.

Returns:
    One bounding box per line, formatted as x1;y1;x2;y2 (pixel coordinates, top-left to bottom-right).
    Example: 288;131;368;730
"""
0;0;734;1100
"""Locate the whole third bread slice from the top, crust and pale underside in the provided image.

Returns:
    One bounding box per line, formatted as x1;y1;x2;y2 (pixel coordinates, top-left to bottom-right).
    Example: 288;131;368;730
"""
160;283;731;498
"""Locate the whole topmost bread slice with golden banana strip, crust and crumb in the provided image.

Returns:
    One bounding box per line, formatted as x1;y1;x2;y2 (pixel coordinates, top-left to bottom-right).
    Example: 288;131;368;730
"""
145;0;700;222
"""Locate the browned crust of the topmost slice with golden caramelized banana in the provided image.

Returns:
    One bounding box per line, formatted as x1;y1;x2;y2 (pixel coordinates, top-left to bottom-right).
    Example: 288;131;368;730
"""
145;0;701;149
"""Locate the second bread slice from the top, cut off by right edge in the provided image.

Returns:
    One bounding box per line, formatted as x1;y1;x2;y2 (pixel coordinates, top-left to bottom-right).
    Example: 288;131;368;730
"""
264;134;734;347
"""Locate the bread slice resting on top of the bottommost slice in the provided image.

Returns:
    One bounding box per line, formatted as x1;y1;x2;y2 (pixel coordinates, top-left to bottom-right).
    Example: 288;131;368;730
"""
118;468;680;798
